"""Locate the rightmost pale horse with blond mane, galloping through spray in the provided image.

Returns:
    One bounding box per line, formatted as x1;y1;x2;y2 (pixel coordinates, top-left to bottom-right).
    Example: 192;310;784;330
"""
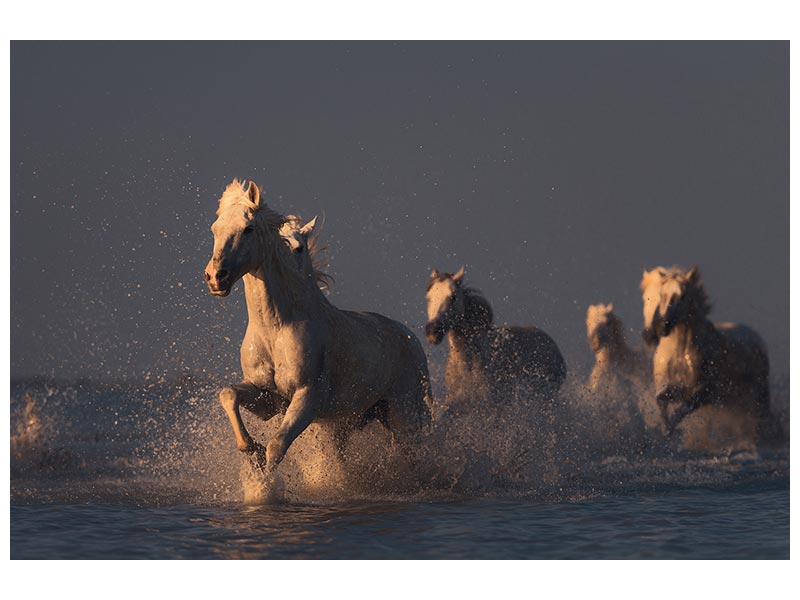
640;267;770;448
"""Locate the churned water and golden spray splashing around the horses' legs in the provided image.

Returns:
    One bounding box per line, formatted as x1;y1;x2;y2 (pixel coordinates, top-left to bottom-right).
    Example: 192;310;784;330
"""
11;380;789;505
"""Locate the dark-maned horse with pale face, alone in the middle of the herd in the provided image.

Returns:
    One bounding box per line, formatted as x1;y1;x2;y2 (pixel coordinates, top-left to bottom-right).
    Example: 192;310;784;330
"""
425;268;566;418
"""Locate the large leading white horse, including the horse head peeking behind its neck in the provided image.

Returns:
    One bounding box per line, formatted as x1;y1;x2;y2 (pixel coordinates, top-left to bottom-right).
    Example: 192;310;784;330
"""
205;179;431;473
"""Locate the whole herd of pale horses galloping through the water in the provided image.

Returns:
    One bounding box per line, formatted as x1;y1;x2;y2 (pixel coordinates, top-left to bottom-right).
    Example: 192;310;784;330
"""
205;179;770;473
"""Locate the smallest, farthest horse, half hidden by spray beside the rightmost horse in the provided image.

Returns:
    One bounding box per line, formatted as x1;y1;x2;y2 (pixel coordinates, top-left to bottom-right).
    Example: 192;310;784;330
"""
586;304;661;438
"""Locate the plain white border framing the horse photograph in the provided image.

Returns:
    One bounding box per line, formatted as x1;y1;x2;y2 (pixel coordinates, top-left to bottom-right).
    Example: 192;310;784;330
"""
0;0;798;600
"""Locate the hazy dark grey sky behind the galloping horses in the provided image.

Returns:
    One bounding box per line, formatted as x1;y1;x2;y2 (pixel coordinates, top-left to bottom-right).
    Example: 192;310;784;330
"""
11;42;789;380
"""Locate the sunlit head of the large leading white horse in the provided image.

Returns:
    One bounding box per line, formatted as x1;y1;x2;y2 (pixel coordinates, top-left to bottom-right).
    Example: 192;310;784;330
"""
204;179;261;296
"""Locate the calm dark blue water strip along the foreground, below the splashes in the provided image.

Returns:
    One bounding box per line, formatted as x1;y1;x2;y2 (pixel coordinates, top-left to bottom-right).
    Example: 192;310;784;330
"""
11;479;789;559
